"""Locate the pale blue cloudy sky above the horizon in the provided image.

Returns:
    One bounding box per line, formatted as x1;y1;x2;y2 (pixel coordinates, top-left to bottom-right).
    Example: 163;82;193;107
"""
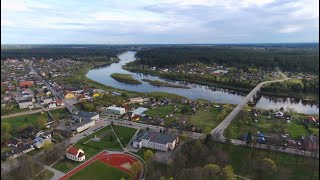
1;0;319;44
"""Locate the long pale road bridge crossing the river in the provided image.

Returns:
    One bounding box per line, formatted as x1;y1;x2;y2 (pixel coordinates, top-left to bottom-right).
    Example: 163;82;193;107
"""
210;71;289;141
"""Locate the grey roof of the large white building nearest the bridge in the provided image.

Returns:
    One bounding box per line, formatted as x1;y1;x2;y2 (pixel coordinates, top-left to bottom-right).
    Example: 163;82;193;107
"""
134;131;178;144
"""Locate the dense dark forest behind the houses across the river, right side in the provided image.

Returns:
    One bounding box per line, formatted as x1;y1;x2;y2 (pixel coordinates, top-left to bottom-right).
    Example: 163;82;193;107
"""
136;47;319;73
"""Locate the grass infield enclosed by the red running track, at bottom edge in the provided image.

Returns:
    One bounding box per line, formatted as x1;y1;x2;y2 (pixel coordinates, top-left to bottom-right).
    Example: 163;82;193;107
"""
69;161;129;180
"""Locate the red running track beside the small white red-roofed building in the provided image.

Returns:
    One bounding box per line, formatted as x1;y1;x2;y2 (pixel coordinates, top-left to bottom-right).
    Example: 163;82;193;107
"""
59;151;138;180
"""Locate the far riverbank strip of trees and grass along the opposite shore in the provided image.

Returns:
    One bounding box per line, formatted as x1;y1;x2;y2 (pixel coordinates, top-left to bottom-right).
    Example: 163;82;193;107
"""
123;66;319;101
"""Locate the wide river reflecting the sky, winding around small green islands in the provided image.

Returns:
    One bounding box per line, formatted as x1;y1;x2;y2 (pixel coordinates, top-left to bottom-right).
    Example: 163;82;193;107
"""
86;51;319;114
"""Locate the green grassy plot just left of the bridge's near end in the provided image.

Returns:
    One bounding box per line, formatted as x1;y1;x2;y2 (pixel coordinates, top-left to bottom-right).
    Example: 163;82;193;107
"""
189;107;229;133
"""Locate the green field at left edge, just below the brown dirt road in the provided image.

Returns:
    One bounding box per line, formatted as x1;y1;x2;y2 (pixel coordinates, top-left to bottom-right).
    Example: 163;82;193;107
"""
1;113;48;131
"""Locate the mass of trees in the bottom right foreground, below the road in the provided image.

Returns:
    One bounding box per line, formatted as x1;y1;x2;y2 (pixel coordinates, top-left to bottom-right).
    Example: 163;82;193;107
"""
145;135;316;180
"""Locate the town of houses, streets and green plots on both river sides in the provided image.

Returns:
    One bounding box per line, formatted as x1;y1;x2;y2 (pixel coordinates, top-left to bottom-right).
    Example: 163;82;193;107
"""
1;52;319;179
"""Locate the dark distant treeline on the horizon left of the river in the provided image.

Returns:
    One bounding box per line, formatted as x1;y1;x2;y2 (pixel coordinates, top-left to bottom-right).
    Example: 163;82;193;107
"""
1;45;126;61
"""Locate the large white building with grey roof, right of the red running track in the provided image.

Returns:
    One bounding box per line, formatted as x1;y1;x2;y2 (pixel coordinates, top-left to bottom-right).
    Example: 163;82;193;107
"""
132;131;179;151
